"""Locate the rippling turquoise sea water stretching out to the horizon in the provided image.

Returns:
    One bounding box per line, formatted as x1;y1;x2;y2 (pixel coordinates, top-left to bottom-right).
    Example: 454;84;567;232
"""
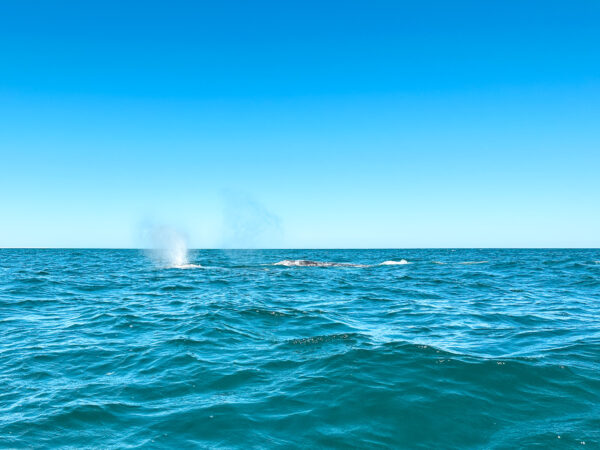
0;250;600;448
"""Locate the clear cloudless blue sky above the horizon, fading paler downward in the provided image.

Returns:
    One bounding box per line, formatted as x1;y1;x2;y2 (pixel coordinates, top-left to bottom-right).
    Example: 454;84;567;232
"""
0;0;600;247
